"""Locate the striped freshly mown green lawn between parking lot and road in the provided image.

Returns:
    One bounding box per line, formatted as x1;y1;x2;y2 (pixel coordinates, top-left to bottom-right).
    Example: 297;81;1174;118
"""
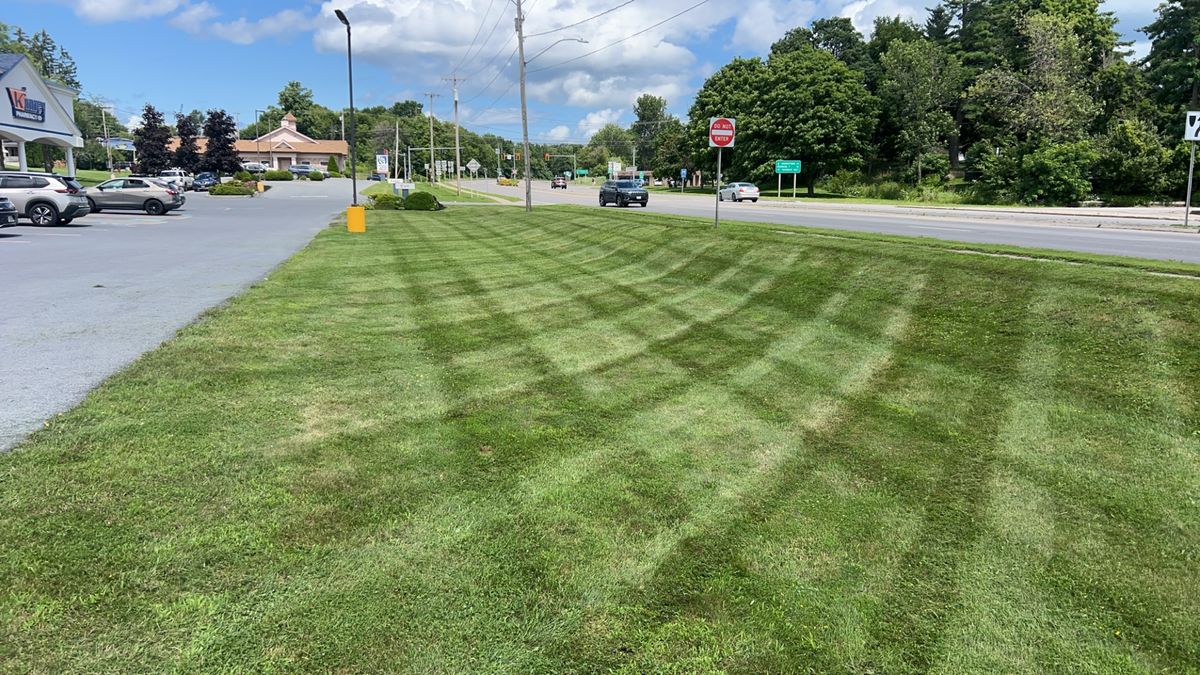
0;207;1200;674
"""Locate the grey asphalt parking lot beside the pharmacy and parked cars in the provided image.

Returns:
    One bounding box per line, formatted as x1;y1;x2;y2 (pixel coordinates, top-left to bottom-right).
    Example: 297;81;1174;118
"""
0;179;350;450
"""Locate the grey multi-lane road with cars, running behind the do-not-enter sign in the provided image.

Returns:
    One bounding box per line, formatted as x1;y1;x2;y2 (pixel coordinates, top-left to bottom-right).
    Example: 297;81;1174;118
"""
469;181;1200;262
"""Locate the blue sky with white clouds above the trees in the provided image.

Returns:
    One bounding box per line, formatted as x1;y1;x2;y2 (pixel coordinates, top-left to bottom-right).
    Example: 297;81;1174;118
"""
0;0;1154;142
